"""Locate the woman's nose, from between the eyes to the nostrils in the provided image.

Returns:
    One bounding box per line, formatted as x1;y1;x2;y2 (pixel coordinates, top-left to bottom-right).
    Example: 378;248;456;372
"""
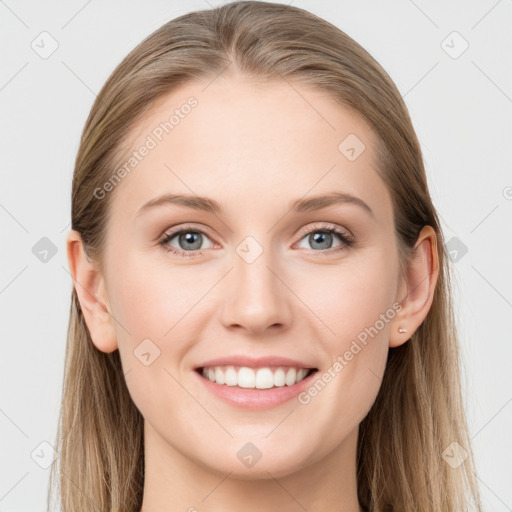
222;241;292;334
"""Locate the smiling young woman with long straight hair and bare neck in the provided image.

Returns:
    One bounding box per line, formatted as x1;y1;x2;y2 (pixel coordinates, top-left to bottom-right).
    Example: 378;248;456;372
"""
49;2;480;512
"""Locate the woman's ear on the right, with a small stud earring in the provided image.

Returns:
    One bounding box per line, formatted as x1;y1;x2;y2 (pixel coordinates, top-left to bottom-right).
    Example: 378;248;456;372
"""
389;226;439;347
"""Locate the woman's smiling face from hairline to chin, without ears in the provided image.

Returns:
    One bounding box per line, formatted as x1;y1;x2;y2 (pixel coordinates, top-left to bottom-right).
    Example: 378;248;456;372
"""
95;77;399;478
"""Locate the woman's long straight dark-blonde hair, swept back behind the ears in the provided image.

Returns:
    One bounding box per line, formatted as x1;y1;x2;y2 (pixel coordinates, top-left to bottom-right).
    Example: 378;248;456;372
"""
48;1;481;512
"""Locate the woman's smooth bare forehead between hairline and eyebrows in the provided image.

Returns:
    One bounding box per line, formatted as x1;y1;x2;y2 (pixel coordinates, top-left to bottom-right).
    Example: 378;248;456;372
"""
106;73;391;218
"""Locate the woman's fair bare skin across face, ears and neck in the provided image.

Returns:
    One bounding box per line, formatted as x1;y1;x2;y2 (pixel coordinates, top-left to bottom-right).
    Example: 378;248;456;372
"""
67;76;437;512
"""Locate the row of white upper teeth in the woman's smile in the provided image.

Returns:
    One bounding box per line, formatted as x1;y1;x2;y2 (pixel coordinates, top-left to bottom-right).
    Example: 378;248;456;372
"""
203;366;309;389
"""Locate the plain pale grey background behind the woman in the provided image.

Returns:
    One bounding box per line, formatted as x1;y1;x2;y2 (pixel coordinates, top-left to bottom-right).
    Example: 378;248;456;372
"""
0;0;512;512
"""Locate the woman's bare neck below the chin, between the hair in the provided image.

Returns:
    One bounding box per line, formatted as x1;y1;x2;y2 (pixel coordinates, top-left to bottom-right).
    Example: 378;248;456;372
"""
140;423;363;512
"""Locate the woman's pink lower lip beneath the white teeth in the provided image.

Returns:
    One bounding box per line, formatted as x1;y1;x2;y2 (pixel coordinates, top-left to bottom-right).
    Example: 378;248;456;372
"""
194;371;318;409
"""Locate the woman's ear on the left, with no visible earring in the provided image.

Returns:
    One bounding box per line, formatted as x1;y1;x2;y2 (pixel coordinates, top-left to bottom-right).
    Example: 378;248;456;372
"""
67;229;118;353
